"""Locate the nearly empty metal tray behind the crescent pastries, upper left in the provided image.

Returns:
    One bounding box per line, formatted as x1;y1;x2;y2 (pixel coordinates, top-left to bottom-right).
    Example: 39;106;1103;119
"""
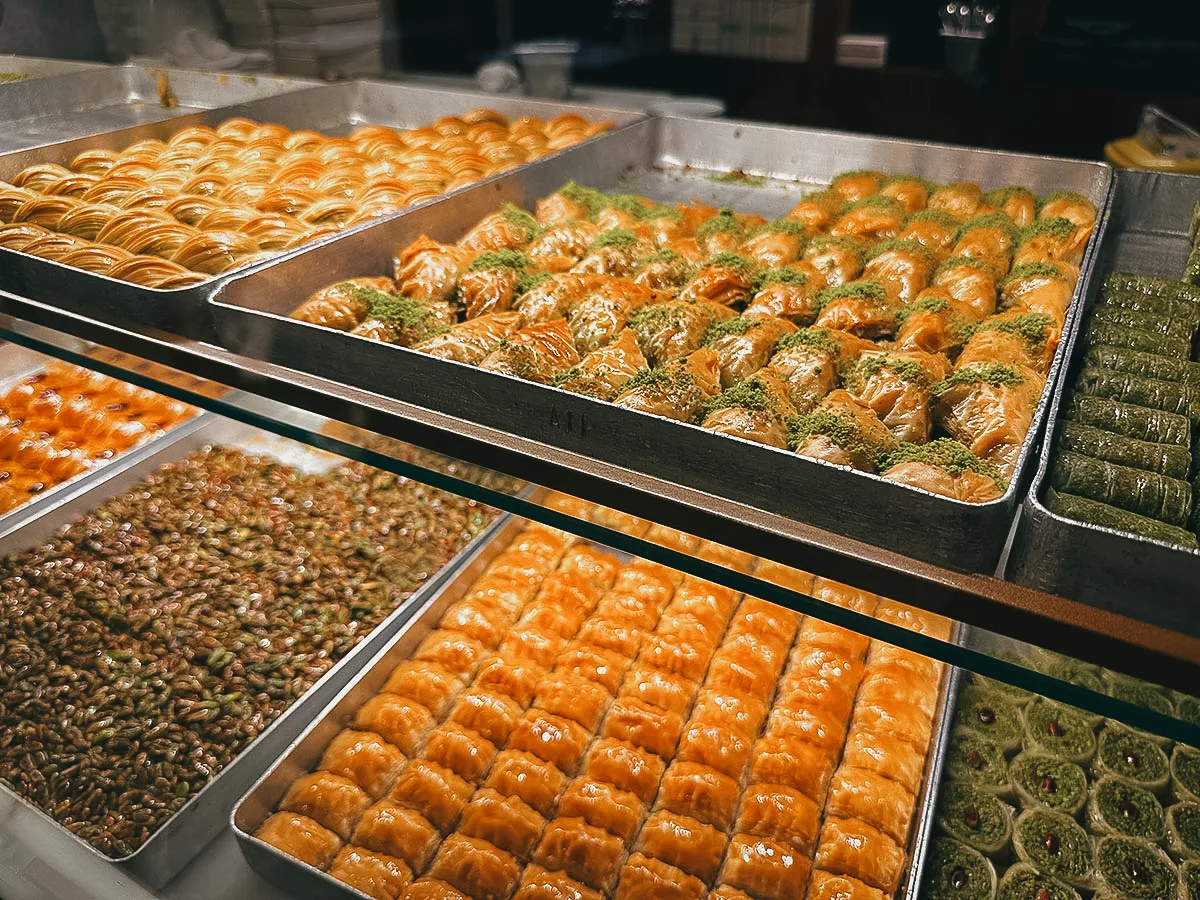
0;64;316;152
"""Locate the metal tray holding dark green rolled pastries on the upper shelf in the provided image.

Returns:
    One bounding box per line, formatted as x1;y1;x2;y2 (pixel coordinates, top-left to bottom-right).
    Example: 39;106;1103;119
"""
1007;170;1200;636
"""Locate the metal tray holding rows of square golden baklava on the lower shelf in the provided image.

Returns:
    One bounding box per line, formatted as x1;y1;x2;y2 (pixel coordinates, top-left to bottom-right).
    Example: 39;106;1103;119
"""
230;518;959;900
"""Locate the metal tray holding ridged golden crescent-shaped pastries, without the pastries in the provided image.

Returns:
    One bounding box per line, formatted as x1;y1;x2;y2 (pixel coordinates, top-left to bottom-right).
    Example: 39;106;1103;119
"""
0;82;644;341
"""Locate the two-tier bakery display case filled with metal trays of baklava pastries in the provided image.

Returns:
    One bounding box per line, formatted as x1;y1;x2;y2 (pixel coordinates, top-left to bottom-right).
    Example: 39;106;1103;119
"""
0;60;1200;900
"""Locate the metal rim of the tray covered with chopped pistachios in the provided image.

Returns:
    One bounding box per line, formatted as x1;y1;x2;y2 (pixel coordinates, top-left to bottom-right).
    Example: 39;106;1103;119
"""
0;414;516;875
